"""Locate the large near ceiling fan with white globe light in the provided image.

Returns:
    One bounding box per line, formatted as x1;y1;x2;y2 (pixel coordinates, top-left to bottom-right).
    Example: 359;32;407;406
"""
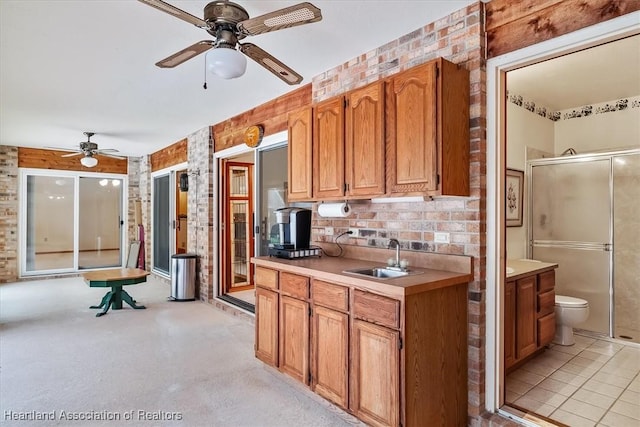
139;0;322;85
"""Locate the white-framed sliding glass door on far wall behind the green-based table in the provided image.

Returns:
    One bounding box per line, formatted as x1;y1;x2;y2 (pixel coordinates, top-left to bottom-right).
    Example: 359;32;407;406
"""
20;170;126;275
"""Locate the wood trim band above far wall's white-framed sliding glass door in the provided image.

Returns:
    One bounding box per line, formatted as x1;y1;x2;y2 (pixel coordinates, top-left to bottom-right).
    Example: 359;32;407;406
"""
18;147;128;175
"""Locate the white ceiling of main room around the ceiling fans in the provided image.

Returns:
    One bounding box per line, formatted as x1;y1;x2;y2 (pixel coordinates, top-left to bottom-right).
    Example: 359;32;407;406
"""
0;0;473;155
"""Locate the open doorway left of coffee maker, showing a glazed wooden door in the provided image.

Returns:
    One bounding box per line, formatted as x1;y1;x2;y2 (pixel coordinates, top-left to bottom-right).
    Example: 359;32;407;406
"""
215;132;287;313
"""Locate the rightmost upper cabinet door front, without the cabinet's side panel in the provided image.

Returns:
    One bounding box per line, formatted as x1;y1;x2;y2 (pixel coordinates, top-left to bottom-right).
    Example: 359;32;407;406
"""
386;62;438;193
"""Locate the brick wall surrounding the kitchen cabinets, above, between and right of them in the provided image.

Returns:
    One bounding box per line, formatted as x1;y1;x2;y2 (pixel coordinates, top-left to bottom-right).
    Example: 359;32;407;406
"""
312;2;490;425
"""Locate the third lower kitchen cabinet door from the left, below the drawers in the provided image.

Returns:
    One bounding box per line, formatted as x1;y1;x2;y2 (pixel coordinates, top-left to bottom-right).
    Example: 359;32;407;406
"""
311;306;349;409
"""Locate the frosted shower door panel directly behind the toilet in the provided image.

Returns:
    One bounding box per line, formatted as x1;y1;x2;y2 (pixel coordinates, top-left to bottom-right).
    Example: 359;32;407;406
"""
529;157;612;335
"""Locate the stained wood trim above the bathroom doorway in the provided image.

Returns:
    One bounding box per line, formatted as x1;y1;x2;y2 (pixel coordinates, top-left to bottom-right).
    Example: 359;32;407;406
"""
485;0;640;58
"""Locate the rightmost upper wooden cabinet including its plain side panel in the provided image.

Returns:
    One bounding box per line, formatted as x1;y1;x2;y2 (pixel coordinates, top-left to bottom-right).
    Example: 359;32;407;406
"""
385;58;470;196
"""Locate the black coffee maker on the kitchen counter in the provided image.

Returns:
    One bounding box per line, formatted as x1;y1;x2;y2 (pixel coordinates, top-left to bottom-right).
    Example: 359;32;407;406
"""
269;207;311;250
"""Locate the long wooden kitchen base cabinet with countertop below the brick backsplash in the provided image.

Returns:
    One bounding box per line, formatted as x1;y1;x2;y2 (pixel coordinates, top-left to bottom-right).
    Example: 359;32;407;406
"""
252;251;473;427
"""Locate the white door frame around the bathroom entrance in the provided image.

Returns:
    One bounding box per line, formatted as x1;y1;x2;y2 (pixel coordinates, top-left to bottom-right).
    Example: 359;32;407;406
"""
485;12;640;414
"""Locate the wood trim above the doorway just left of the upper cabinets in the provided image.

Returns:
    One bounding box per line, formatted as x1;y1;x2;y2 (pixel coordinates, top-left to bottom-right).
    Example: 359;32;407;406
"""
211;83;311;152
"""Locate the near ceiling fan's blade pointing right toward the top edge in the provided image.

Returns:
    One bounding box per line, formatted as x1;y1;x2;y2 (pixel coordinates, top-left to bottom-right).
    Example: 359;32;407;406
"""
238;2;322;36
